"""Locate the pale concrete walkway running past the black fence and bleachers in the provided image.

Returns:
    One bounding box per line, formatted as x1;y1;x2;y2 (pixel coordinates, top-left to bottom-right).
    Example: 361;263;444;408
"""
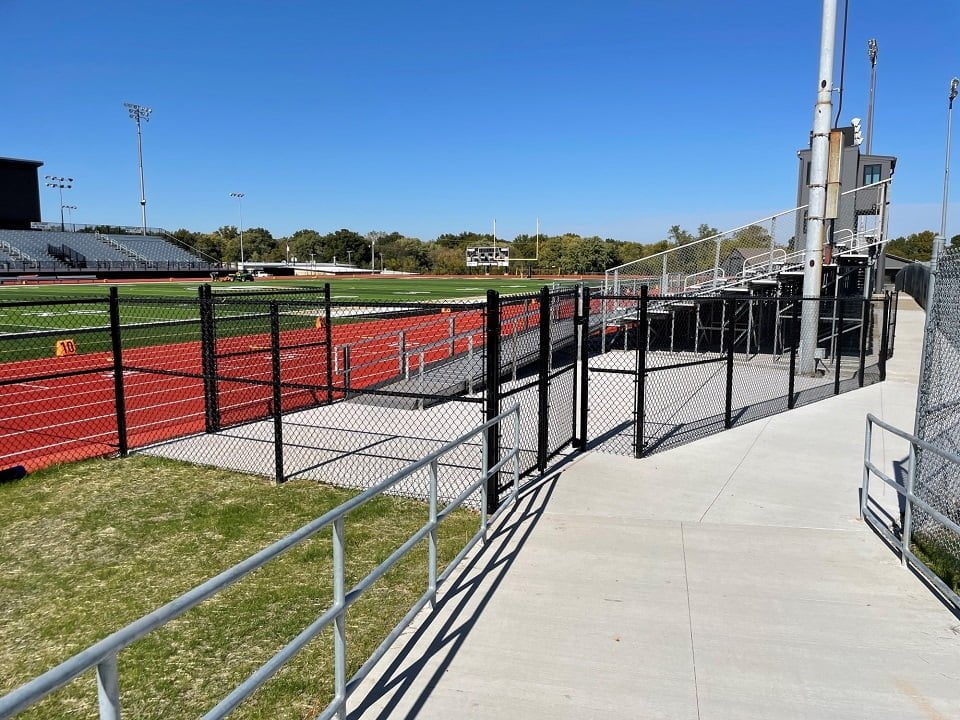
351;301;960;720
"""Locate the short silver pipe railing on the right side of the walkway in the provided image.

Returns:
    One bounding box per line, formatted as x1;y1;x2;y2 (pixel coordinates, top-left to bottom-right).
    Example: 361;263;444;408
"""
860;413;960;607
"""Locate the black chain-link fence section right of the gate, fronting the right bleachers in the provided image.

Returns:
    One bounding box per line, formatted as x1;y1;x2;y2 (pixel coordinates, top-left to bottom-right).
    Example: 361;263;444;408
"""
581;288;892;457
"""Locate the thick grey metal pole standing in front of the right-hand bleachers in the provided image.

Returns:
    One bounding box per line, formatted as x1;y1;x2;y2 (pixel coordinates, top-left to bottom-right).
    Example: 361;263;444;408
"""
799;0;837;375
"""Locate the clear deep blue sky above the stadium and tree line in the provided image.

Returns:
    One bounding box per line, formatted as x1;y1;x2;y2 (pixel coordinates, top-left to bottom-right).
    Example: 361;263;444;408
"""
0;0;960;242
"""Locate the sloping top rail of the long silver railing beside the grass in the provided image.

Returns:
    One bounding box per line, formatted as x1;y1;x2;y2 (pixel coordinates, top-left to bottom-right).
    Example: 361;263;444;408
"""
0;403;520;718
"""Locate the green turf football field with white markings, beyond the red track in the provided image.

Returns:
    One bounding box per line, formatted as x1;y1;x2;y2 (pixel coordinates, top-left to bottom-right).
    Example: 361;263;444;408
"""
0;277;568;362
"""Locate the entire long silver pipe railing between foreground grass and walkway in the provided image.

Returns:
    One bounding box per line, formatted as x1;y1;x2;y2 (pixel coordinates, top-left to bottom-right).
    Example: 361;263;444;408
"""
0;404;520;720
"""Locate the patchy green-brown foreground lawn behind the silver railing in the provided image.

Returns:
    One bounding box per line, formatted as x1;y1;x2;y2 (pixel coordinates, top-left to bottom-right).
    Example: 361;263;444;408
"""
0;456;478;720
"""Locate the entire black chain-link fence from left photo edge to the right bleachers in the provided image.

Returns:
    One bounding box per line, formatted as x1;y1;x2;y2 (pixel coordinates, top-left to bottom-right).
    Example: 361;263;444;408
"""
0;285;895;507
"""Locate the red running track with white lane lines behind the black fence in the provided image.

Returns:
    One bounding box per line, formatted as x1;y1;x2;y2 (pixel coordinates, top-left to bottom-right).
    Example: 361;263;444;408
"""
0;302;552;472
